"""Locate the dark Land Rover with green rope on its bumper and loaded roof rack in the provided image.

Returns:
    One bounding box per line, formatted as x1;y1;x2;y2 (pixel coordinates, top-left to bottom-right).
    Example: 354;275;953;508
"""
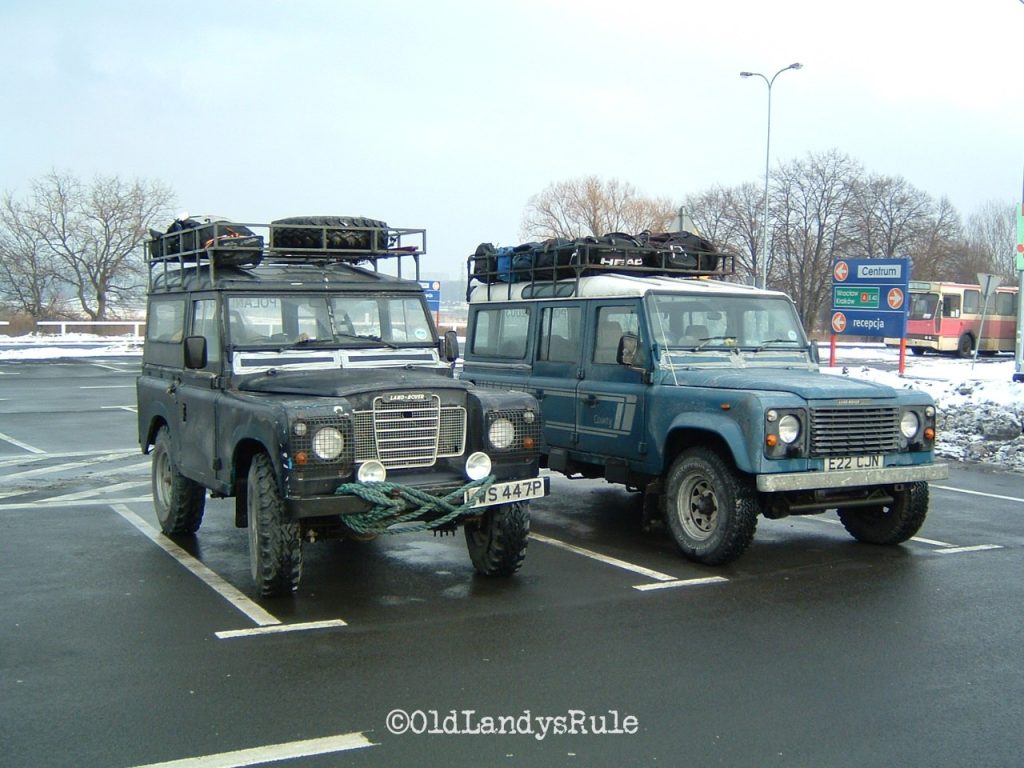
137;216;548;594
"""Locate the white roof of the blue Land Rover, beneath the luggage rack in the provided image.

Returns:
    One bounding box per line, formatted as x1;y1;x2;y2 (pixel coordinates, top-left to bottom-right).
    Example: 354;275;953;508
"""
469;274;778;304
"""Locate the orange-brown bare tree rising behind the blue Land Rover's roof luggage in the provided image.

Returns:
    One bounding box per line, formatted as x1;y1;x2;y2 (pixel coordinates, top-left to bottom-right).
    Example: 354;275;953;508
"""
520;176;676;240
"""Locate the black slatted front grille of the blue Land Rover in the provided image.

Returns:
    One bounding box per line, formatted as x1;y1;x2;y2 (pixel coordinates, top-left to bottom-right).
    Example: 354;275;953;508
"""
811;408;900;456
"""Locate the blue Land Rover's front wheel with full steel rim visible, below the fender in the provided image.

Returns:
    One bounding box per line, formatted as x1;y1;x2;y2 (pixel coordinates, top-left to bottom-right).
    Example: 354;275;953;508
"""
663;449;761;565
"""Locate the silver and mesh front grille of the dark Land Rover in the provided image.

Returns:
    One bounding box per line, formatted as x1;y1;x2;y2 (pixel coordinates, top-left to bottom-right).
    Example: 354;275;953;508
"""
353;395;466;469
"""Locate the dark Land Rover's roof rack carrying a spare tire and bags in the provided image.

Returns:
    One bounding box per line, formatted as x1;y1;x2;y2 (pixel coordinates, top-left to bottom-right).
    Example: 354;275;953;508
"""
145;216;427;290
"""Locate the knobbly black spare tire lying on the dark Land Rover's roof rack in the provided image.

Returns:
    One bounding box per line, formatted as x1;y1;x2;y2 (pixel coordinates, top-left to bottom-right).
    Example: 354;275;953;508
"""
270;216;391;253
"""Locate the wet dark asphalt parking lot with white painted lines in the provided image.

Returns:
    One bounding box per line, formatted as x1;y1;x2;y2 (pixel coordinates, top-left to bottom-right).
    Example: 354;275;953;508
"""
0;357;1024;768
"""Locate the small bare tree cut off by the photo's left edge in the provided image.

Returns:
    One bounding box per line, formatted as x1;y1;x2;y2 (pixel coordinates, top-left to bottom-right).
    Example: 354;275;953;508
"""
0;194;61;319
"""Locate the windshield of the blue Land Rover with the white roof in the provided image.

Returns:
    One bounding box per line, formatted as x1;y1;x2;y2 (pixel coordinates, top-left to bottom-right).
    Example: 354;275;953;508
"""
648;294;807;350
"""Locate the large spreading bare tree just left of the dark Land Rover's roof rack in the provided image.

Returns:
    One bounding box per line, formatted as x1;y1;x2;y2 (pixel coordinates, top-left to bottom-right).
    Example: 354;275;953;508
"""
2;171;172;319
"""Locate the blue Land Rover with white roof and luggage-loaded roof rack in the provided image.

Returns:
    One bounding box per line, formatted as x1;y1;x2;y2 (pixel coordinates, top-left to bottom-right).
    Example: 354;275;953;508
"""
462;233;947;564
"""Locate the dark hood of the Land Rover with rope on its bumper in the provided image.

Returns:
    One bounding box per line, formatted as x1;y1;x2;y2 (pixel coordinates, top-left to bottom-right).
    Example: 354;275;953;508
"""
238;368;469;397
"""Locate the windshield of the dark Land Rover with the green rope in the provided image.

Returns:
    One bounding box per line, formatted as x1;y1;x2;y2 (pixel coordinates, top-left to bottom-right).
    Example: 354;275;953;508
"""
227;294;434;346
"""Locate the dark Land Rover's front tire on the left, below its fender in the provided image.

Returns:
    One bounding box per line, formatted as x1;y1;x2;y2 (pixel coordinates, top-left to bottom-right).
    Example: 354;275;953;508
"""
246;454;302;596
